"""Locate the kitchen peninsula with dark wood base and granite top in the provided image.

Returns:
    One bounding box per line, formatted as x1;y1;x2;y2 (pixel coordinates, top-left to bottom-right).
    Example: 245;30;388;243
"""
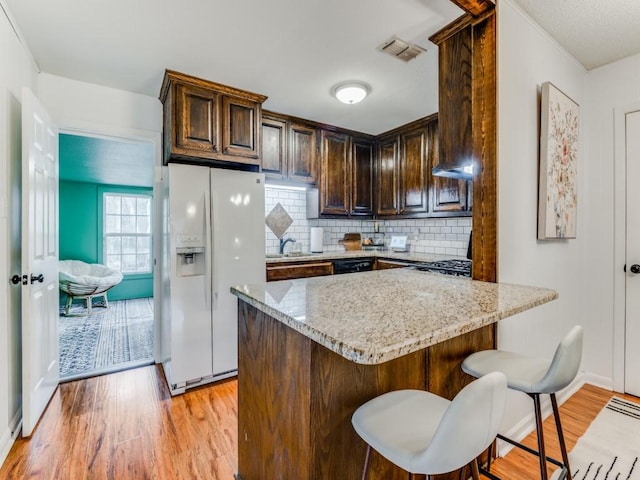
232;269;558;480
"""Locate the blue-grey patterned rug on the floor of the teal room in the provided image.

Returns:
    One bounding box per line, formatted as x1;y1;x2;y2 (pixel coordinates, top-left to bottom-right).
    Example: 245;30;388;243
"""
58;298;153;380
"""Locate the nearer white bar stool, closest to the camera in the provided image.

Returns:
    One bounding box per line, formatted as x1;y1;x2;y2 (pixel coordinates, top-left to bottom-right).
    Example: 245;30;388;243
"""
351;372;507;480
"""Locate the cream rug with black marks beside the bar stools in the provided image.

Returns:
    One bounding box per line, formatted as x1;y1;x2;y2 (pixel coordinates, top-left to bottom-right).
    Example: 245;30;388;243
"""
552;397;640;480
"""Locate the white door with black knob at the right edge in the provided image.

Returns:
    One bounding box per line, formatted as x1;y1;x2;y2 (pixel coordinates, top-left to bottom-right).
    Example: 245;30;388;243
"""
624;111;640;396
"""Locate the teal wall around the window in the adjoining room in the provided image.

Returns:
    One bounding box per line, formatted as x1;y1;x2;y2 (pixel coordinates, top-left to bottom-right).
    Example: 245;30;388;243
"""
60;181;153;300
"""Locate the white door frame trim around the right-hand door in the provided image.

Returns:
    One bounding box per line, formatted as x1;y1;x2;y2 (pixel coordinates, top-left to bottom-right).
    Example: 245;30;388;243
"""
612;102;640;392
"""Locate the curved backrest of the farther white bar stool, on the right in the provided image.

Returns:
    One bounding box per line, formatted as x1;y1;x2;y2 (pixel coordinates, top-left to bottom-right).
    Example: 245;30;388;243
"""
536;325;582;393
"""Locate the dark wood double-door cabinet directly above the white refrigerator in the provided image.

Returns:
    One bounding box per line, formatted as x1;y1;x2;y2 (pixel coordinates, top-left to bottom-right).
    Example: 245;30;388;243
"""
160;70;267;165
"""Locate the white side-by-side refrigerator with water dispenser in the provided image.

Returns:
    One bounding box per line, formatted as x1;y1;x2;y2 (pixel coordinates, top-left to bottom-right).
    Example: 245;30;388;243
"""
162;164;265;395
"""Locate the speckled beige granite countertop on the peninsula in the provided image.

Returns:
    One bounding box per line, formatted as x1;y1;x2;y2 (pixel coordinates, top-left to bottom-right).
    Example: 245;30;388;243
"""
231;268;558;365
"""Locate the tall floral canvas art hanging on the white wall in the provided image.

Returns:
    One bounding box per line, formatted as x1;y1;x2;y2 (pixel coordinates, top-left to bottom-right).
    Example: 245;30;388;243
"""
538;82;580;240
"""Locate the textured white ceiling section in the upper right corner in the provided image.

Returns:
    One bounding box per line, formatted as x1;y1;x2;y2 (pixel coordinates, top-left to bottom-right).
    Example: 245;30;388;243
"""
515;0;640;70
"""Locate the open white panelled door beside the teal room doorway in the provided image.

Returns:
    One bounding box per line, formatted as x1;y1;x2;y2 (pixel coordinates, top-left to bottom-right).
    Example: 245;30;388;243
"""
22;88;59;437
